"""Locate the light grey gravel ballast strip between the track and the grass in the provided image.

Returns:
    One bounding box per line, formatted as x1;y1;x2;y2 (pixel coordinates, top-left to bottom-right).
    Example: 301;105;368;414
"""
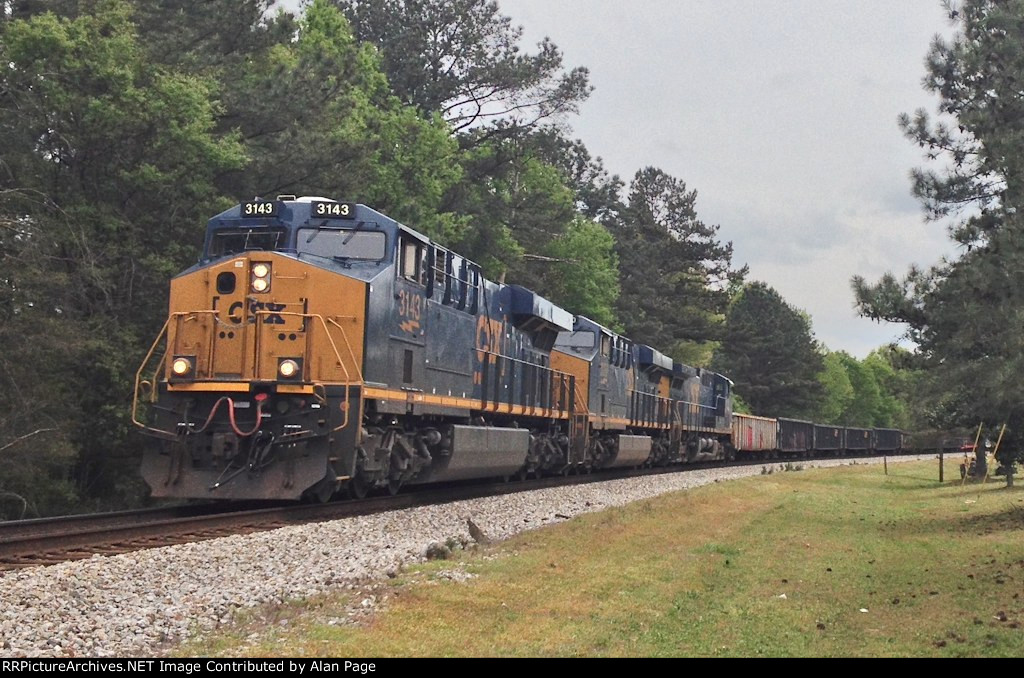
0;457;930;658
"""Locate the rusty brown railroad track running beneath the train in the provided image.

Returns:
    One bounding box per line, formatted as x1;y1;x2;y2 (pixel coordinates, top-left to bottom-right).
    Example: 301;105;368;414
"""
0;461;905;570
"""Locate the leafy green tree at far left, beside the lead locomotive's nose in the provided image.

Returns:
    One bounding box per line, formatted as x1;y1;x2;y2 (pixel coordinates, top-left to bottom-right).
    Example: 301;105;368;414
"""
0;0;244;511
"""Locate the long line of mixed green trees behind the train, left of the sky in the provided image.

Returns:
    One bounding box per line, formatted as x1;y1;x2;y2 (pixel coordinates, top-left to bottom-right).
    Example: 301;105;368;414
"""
0;0;921;517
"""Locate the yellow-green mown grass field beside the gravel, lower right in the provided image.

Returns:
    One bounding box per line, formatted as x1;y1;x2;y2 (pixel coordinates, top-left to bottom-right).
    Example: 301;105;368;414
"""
184;461;1024;656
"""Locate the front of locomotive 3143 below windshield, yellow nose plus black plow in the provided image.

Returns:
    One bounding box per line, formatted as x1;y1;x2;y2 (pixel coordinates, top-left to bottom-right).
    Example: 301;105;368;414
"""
140;251;369;499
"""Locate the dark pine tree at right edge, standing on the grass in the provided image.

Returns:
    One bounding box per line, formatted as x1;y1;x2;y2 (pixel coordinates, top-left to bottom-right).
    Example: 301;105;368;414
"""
853;0;1024;467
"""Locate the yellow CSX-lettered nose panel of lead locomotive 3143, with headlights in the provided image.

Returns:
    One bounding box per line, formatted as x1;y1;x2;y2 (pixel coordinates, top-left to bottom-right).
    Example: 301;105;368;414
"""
165;252;366;391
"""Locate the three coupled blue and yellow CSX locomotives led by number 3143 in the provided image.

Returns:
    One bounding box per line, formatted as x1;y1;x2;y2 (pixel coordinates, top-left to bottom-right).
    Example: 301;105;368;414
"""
133;197;905;500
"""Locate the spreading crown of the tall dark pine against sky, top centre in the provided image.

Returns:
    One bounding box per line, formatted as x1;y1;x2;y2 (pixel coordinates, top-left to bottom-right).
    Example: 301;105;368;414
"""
335;0;591;135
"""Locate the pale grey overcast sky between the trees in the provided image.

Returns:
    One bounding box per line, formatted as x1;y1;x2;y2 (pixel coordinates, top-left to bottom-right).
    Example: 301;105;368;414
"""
499;0;955;357
